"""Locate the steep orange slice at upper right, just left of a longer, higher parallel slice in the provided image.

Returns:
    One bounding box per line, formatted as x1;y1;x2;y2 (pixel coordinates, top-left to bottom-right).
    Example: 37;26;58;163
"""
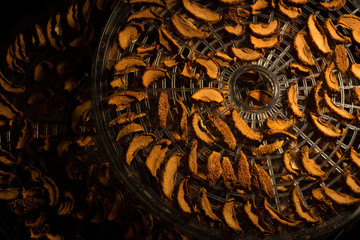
294;31;316;67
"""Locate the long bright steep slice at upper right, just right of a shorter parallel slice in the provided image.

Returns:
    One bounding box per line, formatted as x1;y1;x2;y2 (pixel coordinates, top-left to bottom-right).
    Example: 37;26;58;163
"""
307;13;332;54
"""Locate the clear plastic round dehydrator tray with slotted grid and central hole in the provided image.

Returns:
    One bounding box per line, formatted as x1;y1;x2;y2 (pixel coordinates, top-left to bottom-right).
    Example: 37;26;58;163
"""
92;0;360;239
